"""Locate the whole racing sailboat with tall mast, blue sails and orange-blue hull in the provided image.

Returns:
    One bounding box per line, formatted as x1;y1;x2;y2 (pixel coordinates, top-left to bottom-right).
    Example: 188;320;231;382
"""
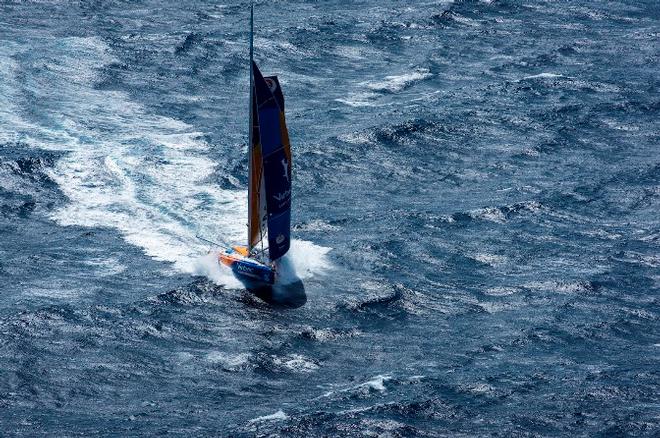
218;4;291;287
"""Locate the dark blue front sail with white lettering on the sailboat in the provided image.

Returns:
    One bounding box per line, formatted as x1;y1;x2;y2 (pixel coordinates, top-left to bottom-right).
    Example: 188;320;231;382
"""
252;62;291;260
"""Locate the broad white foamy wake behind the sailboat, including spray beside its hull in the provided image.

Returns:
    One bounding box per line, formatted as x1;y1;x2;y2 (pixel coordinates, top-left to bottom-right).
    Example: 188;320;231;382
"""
0;37;327;287
